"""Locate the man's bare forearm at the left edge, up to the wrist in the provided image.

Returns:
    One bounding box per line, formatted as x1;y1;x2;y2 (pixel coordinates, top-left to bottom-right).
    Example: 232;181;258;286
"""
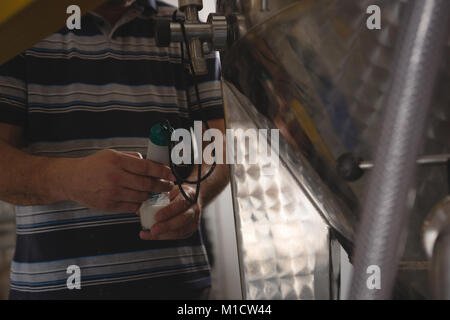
0;140;72;205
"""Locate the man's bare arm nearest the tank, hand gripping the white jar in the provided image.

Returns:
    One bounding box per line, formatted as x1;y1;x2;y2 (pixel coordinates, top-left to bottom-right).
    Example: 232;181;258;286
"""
140;119;230;240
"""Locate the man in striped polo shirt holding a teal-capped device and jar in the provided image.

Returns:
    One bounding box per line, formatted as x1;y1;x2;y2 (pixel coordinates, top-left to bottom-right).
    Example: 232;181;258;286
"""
0;0;228;299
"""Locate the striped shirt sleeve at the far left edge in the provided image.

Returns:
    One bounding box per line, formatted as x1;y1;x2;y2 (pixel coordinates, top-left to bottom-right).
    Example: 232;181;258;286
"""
0;55;28;127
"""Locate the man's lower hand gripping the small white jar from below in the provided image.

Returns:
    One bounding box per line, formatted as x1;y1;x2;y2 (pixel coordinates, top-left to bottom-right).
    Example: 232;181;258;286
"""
139;186;202;240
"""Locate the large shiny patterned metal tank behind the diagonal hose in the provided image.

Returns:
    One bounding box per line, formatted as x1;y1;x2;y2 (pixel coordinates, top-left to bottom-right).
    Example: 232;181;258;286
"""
217;0;450;299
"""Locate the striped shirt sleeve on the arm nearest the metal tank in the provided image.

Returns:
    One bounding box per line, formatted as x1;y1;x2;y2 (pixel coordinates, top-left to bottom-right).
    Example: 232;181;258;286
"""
185;52;224;120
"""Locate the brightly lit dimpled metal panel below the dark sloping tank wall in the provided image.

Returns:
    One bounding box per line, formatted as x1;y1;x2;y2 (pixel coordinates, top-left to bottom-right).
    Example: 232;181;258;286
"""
223;83;339;299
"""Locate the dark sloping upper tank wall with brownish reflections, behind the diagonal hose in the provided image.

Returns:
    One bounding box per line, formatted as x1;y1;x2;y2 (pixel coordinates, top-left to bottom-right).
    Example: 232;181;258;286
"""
218;0;450;298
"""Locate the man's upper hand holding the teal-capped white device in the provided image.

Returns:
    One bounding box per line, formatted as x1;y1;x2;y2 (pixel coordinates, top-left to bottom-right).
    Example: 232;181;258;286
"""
61;150;175;212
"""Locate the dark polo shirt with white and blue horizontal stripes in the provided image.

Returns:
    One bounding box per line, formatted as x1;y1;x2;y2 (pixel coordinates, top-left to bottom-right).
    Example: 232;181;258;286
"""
0;1;223;299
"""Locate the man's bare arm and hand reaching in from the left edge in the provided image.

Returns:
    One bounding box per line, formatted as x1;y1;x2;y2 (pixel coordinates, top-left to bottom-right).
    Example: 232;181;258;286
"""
0;124;174;212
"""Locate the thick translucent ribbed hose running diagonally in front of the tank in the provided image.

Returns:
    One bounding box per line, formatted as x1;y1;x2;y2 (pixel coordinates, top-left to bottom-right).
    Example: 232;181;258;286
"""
350;0;450;299
